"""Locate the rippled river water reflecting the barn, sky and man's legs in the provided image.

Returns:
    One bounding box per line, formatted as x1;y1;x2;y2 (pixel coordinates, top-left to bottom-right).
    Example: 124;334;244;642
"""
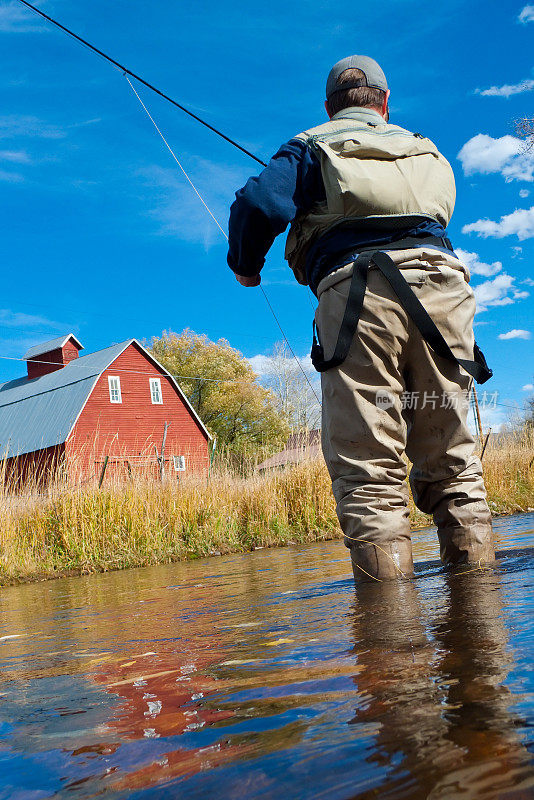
0;514;534;800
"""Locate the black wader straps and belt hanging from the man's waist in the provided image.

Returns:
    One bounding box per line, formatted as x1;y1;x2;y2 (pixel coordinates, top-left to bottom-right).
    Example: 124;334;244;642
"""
311;236;493;383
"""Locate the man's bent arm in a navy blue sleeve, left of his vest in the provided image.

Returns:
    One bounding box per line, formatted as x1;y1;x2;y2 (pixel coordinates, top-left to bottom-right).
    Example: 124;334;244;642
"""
228;139;325;286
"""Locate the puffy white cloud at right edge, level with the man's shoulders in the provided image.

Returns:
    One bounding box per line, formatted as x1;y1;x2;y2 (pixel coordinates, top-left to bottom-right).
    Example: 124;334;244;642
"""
458;133;534;183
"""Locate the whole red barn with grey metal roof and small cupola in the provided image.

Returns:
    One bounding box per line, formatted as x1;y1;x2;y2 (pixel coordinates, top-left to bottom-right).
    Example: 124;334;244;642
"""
0;334;211;483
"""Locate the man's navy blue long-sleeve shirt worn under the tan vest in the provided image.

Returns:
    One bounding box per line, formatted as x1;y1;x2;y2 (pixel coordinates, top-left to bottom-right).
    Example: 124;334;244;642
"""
228;109;447;292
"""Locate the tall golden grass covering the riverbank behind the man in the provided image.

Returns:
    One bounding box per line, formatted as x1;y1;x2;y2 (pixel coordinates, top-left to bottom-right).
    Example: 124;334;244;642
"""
0;431;534;585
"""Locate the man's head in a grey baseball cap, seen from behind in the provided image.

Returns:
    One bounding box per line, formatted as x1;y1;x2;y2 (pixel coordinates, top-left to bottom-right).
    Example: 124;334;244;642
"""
325;56;389;121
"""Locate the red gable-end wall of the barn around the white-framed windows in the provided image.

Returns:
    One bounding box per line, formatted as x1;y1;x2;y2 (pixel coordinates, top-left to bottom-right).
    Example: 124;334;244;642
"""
66;344;209;477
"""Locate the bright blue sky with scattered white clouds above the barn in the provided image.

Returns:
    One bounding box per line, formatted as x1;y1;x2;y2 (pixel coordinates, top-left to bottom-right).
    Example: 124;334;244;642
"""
0;0;534;424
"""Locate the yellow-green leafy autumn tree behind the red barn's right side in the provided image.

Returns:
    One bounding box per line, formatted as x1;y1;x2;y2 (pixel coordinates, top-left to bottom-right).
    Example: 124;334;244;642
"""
148;329;289;456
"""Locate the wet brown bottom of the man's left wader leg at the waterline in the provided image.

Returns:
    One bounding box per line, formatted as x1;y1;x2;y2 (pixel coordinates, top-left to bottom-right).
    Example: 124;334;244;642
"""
350;539;413;583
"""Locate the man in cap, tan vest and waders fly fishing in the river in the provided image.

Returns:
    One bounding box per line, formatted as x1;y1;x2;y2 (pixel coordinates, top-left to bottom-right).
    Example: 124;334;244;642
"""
228;56;494;580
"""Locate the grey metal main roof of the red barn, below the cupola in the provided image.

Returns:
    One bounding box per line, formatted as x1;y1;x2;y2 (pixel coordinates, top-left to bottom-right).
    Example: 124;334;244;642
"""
0;337;211;459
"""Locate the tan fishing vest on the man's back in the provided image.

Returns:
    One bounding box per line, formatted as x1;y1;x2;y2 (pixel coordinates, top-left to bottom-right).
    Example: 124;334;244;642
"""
285;117;456;284
